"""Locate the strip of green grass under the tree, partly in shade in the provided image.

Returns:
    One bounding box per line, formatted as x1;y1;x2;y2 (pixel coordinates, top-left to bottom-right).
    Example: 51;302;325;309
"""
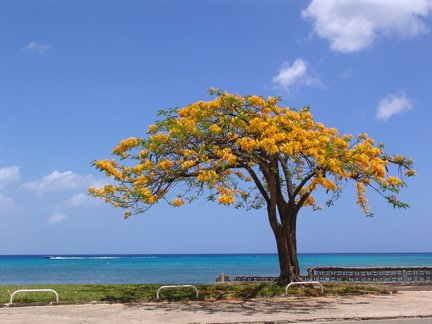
0;283;387;304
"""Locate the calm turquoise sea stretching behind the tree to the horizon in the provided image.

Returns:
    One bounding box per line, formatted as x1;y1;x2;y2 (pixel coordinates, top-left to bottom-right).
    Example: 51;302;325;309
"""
0;253;432;285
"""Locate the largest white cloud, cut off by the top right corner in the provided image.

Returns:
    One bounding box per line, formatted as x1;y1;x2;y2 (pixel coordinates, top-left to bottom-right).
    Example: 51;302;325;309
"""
302;0;432;53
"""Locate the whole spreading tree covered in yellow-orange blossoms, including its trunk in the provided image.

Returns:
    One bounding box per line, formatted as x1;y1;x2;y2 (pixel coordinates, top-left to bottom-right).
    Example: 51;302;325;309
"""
89;89;415;281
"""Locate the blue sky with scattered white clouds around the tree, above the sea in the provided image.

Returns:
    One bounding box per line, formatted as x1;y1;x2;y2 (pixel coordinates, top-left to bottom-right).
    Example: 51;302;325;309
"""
0;0;432;254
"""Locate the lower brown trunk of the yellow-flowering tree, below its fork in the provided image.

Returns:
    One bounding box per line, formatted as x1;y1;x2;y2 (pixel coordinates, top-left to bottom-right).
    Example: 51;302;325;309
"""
274;226;300;282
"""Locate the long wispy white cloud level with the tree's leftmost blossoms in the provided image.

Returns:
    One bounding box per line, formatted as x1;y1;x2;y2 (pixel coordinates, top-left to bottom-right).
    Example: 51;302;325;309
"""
21;171;98;195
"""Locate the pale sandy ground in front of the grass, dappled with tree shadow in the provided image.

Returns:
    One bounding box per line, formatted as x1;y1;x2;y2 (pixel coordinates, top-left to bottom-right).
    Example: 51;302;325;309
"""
0;291;432;324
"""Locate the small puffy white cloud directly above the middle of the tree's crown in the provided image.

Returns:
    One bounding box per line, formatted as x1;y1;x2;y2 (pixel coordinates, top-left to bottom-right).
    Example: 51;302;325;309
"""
273;58;321;92
